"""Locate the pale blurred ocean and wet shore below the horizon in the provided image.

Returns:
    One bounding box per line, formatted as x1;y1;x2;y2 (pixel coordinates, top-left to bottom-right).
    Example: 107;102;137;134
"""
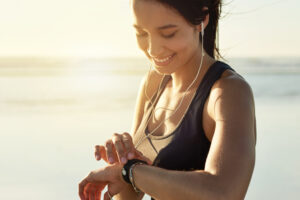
0;57;300;200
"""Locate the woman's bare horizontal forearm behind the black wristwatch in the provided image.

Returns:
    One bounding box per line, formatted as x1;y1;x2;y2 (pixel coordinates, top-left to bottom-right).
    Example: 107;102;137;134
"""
133;165;226;200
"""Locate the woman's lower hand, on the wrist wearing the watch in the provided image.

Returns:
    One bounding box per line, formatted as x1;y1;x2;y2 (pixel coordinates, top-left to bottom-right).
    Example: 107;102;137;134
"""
79;164;127;200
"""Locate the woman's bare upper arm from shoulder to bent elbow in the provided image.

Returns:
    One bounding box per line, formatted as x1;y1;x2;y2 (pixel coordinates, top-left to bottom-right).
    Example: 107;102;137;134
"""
205;76;256;199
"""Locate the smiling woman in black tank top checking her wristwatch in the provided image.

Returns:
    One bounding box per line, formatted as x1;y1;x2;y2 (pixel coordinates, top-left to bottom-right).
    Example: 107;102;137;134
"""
79;0;256;200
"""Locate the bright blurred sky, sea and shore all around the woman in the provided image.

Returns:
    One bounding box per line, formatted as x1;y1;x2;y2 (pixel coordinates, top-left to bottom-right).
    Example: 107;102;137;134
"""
0;0;300;200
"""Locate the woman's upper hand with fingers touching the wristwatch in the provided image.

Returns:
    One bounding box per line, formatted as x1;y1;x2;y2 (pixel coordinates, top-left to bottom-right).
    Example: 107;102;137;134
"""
95;133;152;165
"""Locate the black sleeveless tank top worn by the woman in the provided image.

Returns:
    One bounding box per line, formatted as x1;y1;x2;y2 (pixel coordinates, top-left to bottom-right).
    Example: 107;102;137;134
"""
133;61;235;199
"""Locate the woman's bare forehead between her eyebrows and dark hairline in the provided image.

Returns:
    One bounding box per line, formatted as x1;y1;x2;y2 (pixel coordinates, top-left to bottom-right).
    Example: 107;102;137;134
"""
132;0;187;29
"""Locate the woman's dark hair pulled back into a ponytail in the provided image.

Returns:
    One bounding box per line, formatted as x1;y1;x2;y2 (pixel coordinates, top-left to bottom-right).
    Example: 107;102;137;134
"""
155;0;221;58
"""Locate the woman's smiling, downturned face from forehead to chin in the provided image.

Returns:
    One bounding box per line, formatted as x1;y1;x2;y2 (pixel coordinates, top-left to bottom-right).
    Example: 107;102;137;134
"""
132;0;199;74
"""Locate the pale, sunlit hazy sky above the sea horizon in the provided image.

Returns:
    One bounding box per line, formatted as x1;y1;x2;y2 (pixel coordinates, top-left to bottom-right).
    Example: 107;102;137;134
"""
0;0;300;57
